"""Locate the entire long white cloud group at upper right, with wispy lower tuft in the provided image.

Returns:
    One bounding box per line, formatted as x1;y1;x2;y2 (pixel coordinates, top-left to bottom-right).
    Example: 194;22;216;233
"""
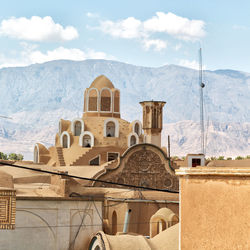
97;12;205;50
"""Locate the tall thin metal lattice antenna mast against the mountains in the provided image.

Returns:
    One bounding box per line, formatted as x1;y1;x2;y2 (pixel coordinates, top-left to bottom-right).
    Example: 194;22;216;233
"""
199;48;205;154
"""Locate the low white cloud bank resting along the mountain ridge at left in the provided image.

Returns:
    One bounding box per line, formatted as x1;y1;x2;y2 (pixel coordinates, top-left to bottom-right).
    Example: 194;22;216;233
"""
0;44;115;68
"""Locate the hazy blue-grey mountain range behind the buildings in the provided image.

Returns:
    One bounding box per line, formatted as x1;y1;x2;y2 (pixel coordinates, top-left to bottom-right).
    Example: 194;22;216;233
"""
0;60;250;158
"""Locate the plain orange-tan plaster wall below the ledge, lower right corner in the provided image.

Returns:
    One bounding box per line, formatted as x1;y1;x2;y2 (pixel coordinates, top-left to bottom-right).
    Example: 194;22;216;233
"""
180;174;250;250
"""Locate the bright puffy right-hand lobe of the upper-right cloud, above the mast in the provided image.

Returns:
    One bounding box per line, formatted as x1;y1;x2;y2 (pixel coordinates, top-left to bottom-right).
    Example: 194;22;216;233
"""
143;12;205;41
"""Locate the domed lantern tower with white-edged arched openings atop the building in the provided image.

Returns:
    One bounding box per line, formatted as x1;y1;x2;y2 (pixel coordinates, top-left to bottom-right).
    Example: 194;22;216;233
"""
83;75;120;118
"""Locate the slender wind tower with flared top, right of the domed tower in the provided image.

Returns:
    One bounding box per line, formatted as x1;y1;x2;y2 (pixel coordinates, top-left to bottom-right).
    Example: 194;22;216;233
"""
140;101;166;147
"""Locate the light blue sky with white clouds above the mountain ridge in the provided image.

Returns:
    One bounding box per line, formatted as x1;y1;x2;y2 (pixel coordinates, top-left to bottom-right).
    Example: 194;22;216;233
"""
0;0;250;72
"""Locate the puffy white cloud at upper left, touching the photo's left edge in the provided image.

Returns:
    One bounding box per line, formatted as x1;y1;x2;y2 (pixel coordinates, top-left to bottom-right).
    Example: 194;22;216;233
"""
0;16;78;42
